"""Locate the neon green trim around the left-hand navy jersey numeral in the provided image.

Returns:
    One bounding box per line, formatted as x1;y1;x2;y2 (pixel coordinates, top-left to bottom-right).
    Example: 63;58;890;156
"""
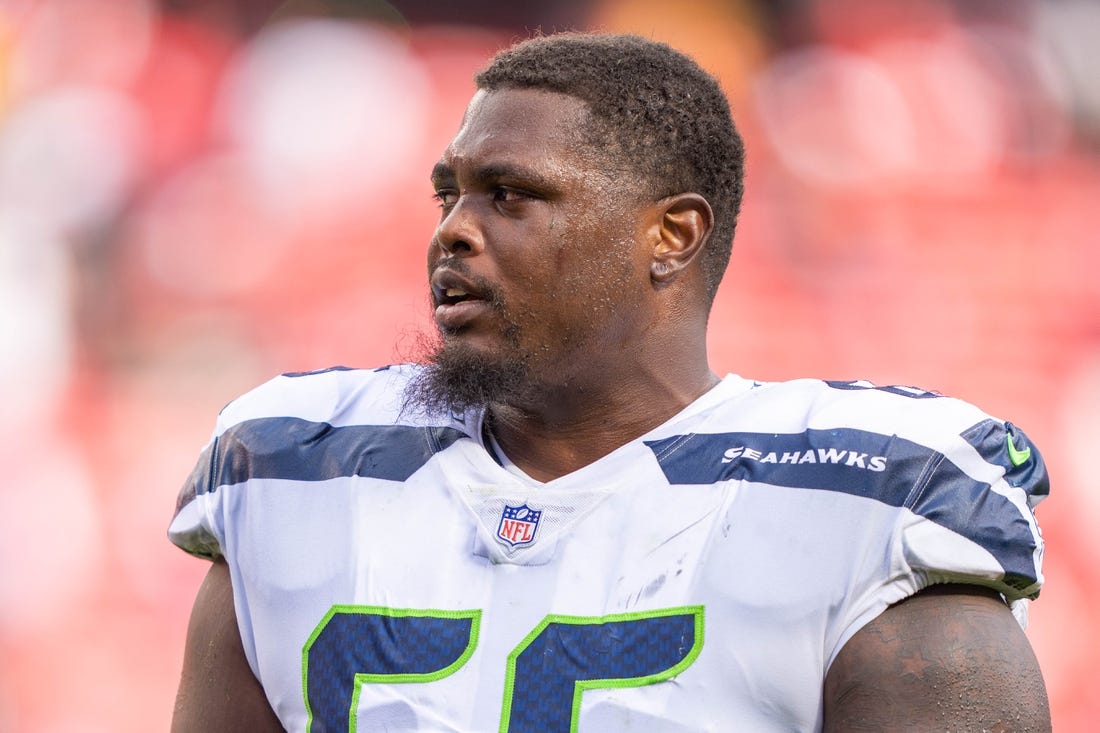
301;605;482;733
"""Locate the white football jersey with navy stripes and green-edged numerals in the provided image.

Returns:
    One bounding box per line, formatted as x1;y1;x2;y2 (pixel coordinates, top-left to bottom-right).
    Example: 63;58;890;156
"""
169;367;1047;733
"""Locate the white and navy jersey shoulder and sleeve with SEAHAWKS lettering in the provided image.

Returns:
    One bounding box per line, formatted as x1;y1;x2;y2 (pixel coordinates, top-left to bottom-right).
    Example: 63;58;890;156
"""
648;380;1048;600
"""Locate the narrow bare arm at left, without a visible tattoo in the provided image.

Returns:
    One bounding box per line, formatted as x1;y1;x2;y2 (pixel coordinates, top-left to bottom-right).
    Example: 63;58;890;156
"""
172;560;283;733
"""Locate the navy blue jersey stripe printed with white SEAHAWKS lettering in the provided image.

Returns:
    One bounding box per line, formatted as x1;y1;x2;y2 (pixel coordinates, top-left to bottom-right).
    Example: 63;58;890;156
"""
646;428;1036;590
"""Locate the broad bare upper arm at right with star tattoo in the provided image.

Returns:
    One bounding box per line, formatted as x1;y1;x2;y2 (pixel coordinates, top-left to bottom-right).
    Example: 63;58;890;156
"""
824;586;1051;733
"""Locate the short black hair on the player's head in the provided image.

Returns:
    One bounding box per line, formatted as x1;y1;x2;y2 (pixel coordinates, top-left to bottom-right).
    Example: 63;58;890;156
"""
474;32;745;299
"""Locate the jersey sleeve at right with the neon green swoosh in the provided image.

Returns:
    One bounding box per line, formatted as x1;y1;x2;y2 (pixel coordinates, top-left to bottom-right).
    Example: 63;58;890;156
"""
900;418;1049;611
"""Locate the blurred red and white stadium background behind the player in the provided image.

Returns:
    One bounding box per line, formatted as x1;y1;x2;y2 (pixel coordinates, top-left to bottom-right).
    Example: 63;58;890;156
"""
0;0;1100;733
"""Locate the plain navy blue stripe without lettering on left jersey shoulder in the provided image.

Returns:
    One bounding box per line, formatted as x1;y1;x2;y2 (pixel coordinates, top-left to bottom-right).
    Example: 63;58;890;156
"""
178;417;463;507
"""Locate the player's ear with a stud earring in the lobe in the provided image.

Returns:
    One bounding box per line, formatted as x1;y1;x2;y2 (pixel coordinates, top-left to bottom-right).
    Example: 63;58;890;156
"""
649;194;714;285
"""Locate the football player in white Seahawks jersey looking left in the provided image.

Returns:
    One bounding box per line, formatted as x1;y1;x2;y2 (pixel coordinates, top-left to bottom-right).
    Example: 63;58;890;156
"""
169;34;1049;733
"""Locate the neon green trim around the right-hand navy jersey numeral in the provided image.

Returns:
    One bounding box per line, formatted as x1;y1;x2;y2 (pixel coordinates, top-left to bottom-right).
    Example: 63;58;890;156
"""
499;605;704;733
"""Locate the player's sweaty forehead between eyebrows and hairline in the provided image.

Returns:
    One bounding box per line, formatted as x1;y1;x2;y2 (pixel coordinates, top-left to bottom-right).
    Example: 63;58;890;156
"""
441;89;587;176
